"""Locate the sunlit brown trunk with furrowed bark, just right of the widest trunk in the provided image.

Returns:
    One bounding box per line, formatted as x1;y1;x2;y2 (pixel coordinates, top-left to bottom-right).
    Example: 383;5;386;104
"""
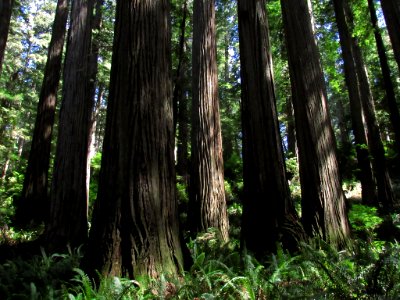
189;0;229;241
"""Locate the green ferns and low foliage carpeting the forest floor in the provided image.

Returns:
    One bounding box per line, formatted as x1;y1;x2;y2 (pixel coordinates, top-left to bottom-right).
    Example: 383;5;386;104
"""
0;204;400;300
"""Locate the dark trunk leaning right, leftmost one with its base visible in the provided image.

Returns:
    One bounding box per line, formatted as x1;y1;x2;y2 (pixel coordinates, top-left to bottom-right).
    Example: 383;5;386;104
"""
16;0;68;225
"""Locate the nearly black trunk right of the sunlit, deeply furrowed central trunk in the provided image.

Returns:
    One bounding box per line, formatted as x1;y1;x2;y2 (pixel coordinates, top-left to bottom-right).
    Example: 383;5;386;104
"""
238;0;301;257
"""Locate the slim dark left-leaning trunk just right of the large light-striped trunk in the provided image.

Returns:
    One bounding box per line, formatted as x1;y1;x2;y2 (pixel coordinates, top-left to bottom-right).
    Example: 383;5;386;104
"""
333;0;377;204
